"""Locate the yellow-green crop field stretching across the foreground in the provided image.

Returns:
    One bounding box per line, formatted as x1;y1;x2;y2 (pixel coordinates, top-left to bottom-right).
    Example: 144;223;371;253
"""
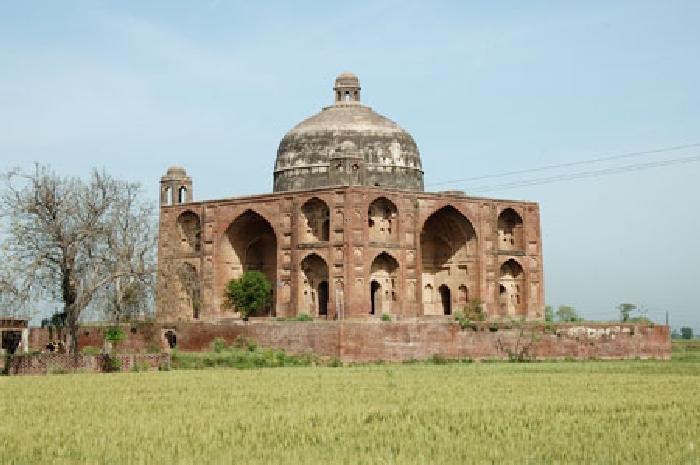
0;354;700;463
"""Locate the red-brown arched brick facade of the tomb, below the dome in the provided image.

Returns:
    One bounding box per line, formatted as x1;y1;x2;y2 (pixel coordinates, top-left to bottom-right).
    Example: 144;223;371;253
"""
158;187;544;320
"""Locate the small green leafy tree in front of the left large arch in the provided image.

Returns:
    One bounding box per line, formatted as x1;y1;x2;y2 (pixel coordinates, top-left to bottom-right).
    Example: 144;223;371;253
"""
224;271;272;320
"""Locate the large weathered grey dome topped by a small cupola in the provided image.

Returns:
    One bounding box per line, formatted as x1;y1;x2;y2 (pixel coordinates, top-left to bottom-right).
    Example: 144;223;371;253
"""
274;73;423;192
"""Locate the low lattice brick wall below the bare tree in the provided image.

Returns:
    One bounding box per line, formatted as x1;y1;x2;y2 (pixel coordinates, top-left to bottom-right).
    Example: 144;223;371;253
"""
5;354;170;375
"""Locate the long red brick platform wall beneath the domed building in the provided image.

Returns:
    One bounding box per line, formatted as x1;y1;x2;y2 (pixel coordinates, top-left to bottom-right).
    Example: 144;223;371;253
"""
23;318;671;362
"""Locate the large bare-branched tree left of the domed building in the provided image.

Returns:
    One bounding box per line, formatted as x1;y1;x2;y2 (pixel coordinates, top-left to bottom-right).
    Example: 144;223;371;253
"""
0;165;157;355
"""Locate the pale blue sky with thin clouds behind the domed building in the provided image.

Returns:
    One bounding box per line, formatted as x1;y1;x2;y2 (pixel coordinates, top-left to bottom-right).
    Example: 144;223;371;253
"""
0;0;700;332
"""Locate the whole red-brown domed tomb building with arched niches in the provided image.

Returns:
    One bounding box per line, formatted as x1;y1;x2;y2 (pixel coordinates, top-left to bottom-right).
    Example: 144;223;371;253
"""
157;73;544;321
